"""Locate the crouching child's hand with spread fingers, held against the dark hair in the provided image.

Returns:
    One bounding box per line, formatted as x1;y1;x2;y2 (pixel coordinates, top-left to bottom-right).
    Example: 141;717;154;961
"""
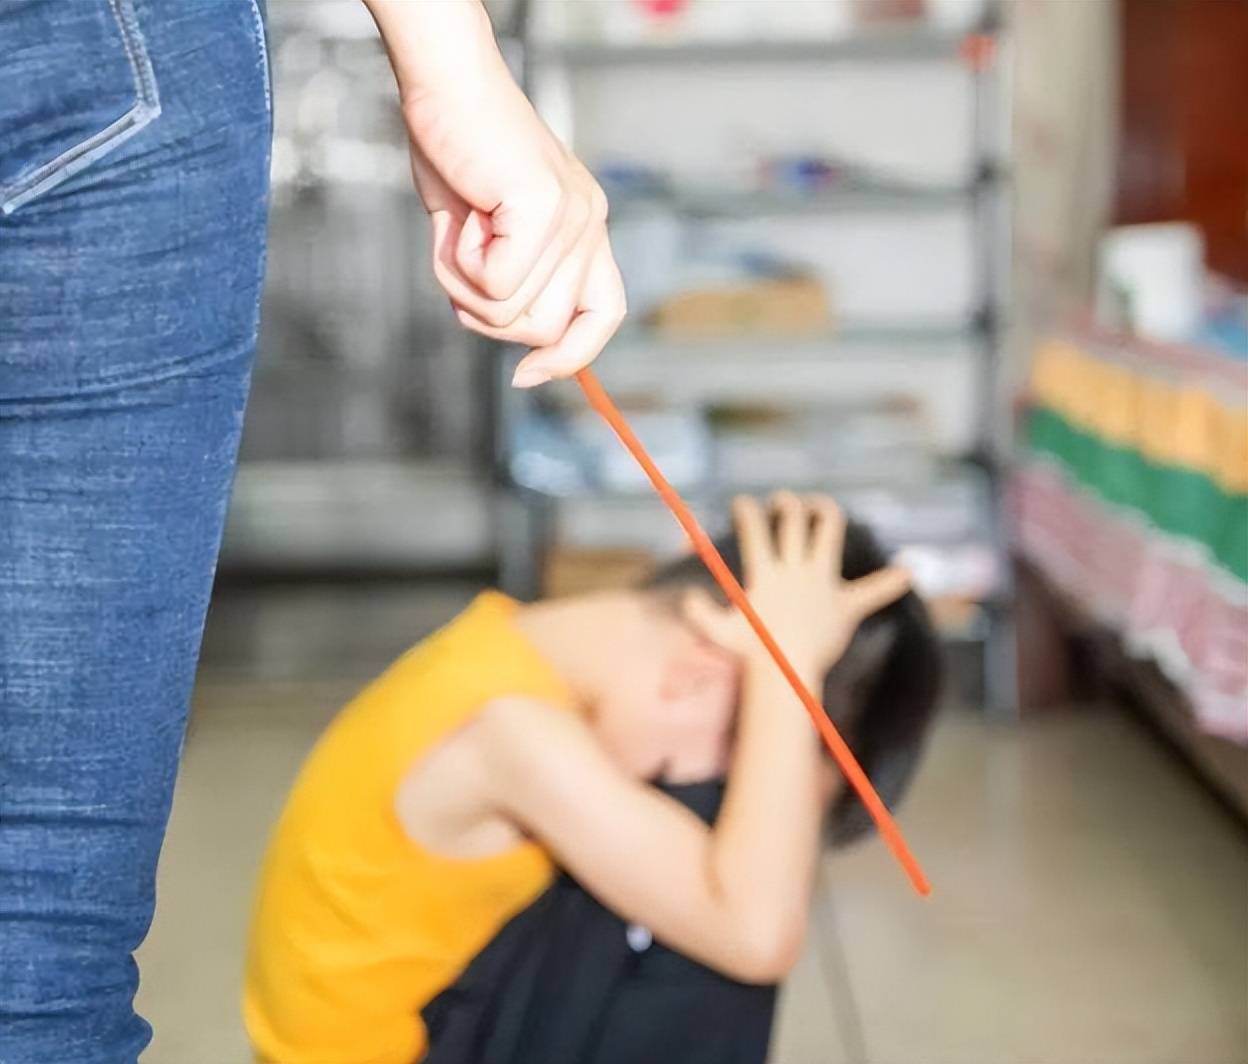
683;491;910;675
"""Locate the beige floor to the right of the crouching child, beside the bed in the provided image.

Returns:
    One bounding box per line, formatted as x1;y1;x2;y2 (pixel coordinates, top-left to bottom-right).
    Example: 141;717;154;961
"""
776;711;1248;1064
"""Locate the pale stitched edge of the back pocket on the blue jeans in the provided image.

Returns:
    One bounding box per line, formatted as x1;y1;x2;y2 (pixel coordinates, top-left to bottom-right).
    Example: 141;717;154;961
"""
0;0;160;215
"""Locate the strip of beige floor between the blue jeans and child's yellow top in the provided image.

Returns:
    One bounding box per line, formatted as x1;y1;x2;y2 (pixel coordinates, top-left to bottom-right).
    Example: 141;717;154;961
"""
139;684;356;1064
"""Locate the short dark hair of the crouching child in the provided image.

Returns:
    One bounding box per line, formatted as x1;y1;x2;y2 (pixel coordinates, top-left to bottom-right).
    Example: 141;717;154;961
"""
645;520;942;846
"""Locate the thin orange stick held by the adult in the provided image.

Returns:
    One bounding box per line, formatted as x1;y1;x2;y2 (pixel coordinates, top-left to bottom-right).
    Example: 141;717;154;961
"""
577;369;931;896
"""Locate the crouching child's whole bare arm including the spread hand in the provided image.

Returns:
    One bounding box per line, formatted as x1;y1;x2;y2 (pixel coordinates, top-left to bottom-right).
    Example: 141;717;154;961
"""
482;496;906;982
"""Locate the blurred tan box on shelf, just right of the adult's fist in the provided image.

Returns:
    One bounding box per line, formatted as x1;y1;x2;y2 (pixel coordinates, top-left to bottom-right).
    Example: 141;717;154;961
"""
653;277;832;339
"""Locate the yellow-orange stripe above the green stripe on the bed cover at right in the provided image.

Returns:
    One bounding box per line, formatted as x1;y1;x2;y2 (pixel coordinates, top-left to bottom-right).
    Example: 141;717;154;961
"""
1028;341;1248;494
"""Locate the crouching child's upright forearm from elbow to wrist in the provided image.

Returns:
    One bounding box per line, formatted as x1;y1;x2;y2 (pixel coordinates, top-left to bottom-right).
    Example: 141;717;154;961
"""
711;656;821;970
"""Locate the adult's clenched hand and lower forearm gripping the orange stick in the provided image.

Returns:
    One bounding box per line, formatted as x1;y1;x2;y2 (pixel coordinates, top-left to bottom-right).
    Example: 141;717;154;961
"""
366;0;625;387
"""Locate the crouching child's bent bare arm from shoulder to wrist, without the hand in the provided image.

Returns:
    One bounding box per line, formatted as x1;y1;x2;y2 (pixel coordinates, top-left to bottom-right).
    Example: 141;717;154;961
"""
477;693;819;983
